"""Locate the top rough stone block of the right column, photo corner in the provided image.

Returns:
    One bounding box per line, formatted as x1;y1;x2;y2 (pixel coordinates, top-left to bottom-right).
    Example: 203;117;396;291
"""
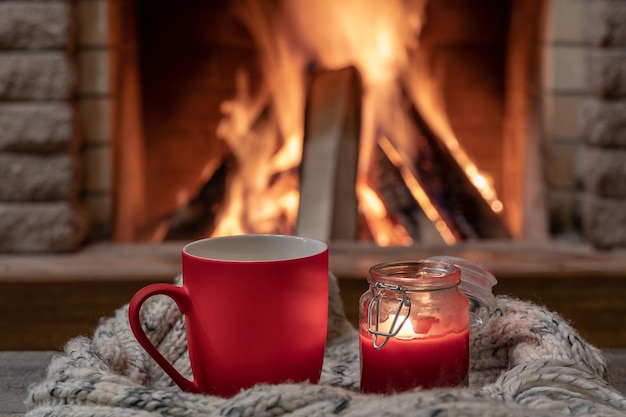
587;0;626;46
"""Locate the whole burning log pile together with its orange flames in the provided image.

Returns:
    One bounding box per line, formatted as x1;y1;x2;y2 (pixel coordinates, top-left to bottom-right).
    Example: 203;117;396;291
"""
160;1;509;245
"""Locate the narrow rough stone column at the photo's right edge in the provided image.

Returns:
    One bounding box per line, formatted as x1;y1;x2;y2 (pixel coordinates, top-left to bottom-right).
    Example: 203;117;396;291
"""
578;0;626;248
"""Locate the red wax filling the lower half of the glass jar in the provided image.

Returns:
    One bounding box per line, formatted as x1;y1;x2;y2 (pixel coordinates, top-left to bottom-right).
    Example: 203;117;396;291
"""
360;329;469;393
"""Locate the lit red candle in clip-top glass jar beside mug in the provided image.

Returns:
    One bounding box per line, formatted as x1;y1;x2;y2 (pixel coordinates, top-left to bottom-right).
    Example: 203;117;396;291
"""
359;260;469;393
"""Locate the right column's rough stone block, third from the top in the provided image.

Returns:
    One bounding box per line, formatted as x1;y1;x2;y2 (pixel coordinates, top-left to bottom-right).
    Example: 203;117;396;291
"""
580;99;626;146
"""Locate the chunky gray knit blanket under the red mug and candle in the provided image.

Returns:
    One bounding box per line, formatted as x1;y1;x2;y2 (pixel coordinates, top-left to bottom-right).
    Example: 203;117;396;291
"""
26;274;626;417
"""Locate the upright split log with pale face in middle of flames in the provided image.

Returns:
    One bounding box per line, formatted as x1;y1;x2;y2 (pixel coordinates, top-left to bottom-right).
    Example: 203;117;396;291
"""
296;68;361;241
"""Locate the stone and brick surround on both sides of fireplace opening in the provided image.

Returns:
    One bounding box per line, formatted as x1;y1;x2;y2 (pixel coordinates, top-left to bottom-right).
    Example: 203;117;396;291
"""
0;0;626;252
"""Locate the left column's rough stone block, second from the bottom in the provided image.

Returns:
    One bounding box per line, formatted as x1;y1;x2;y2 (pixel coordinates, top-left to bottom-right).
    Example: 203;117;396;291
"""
0;152;77;201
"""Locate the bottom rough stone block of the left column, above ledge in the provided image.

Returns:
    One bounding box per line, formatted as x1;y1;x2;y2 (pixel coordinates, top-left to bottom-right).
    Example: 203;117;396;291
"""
0;201;87;253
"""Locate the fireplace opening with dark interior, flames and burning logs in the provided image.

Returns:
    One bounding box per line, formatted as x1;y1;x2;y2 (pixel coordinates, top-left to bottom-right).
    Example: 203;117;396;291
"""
115;0;520;245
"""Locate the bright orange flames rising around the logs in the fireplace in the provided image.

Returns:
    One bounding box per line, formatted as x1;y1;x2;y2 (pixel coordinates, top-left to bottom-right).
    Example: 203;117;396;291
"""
212;0;502;246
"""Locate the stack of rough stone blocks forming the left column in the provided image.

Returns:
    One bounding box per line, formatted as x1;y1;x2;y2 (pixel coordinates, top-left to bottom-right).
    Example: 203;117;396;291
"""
0;1;86;252
